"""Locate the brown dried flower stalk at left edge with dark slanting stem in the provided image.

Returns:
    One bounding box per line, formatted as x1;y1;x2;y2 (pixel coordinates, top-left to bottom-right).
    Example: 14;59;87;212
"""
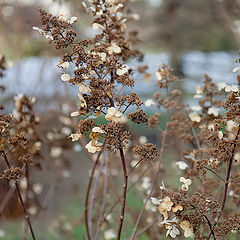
0;57;37;240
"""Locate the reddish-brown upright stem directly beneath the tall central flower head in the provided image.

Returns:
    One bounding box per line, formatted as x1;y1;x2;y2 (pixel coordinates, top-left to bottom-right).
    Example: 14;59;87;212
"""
117;148;128;240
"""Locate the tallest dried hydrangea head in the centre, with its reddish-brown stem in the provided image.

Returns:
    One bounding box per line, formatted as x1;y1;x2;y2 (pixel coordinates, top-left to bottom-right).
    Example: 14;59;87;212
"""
32;0;153;239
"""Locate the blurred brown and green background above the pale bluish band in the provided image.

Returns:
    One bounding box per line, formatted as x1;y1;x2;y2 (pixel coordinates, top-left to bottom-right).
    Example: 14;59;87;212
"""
0;0;240;60
